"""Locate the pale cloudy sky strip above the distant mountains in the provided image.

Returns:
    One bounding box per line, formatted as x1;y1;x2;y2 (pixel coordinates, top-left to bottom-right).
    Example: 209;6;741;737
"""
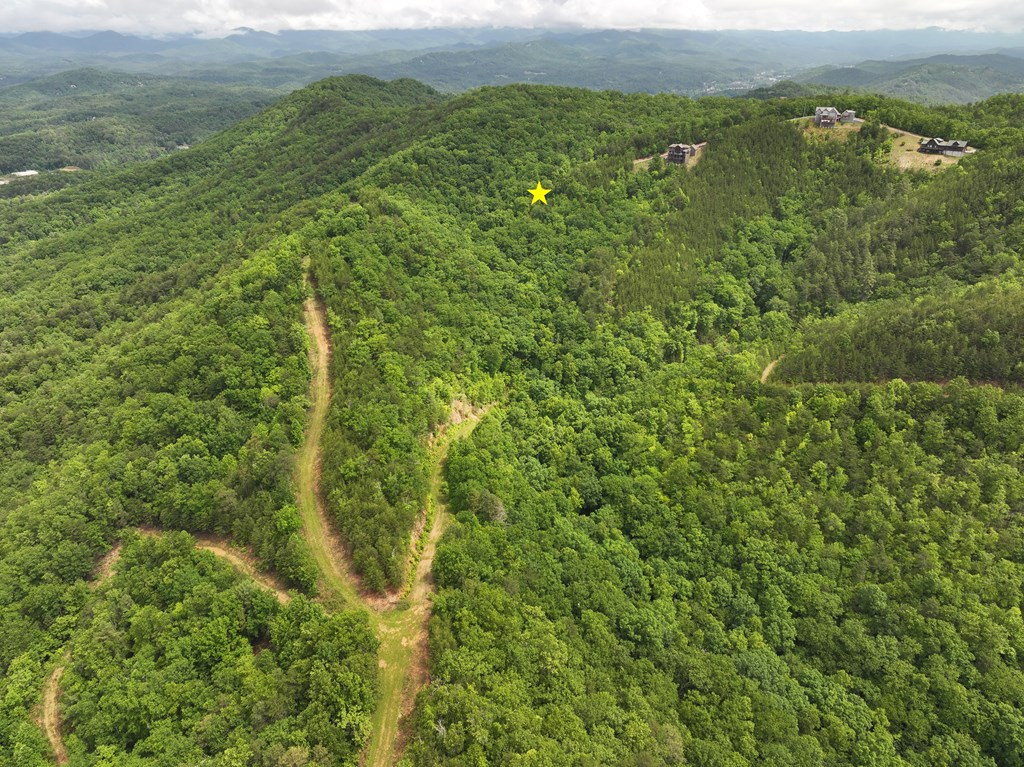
0;0;1024;33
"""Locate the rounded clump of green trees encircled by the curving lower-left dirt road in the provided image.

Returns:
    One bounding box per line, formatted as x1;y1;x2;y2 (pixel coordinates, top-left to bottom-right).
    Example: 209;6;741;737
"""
61;534;377;767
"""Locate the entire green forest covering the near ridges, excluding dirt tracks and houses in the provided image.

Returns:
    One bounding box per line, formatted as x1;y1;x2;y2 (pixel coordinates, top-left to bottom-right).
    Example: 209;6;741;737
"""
0;77;1024;767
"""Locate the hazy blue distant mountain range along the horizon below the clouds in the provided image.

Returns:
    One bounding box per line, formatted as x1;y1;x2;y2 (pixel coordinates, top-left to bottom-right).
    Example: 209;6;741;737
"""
0;29;1024;102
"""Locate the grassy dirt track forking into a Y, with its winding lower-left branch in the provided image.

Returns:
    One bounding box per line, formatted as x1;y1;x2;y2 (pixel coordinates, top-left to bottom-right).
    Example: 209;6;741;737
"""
39;268;486;767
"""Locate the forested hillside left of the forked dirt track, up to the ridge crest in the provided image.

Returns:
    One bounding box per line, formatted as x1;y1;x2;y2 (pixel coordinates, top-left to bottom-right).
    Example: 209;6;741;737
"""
0;78;436;764
